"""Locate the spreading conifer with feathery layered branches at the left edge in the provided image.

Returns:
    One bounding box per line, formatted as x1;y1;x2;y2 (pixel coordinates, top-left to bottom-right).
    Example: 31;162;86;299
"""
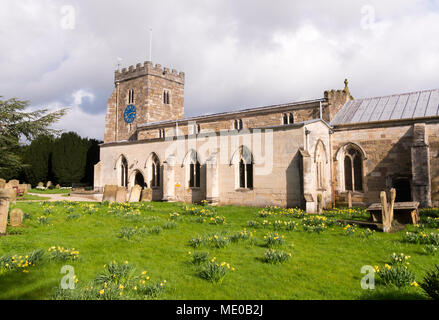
0;96;67;179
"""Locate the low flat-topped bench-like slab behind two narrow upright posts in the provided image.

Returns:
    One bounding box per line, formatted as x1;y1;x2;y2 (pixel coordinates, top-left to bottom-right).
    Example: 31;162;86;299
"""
367;201;420;224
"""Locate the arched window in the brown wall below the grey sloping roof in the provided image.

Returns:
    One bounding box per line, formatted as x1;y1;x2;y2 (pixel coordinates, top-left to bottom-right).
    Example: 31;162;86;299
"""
343;147;363;191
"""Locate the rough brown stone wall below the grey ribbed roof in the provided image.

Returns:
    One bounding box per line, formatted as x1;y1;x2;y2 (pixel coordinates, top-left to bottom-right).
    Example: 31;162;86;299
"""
332;123;439;204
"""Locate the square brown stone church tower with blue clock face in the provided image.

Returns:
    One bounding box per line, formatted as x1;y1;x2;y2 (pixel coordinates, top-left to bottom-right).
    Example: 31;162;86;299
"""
104;61;184;143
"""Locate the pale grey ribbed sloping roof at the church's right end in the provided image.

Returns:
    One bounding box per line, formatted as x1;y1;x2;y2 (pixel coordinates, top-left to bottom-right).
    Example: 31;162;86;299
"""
331;89;439;125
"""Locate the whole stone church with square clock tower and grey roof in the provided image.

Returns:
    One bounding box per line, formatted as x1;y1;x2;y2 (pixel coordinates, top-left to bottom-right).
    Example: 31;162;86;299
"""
94;61;439;212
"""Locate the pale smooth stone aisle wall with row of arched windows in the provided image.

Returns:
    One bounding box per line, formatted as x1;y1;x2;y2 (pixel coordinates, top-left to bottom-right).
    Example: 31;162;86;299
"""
100;121;331;207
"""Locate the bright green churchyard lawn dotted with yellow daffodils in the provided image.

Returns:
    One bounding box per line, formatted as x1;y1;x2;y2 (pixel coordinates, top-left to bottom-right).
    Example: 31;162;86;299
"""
0;201;439;300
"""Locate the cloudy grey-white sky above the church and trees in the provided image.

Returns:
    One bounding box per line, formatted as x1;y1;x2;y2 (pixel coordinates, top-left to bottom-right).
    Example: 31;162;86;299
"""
0;0;439;139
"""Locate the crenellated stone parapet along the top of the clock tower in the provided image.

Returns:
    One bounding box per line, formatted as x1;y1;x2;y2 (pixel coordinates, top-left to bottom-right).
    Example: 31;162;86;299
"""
114;61;185;84
